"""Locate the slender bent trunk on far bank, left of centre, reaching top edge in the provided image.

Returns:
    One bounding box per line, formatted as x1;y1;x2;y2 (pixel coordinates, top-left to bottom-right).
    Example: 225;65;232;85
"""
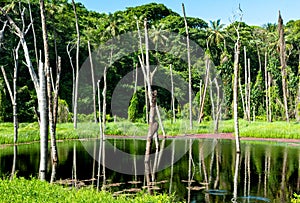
72;0;80;129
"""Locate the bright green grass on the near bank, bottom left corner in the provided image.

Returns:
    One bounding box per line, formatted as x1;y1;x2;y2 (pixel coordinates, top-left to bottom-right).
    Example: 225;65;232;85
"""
0;178;176;203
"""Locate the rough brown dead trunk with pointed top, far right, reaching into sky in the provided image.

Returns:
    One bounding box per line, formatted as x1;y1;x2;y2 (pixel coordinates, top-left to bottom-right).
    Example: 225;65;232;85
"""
278;11;290;122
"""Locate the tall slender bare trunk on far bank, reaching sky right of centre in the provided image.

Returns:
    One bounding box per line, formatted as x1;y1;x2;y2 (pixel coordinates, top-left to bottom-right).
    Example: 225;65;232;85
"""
182;3;193;129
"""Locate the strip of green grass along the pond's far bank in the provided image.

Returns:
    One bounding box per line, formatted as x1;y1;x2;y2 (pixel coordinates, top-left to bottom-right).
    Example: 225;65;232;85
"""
0;120;300;144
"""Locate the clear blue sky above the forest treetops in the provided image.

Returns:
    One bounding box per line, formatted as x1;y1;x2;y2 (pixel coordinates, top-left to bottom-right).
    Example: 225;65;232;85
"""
75;0;300;25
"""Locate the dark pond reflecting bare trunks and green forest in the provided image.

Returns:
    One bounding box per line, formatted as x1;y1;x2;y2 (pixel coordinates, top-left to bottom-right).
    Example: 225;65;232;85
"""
0;138;300;202
